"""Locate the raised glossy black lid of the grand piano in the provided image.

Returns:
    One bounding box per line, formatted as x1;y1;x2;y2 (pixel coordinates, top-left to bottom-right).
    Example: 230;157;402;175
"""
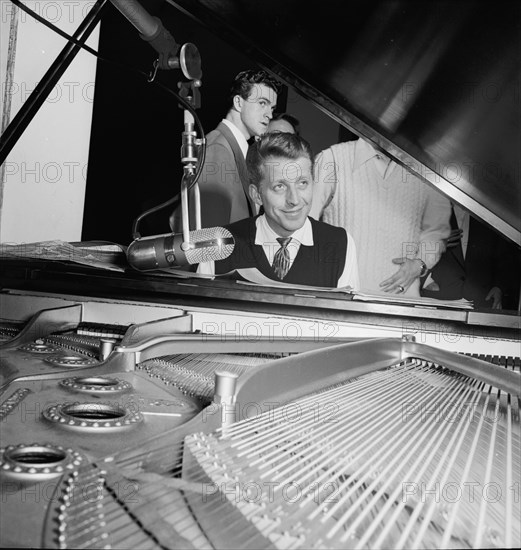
167;0;521;245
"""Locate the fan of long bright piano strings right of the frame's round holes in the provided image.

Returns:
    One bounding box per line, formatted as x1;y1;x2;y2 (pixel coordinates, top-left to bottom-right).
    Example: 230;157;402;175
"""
178;361;519;548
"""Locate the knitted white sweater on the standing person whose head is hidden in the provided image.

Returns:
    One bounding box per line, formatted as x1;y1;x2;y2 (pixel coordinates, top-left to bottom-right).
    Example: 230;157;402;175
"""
310;139;450;296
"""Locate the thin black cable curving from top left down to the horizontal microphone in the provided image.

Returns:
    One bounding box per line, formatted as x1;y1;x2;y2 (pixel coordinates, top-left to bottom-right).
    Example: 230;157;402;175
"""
11;0;206;239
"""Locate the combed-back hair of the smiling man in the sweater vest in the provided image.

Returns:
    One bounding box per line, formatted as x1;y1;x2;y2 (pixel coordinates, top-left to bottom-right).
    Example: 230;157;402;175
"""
246;132;314;187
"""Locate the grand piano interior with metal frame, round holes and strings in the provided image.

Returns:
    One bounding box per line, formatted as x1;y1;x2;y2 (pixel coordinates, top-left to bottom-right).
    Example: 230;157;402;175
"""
0;295;521;549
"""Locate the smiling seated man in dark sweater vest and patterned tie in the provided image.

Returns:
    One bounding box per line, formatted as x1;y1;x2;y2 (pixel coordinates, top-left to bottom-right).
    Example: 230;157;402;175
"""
199;132;359;289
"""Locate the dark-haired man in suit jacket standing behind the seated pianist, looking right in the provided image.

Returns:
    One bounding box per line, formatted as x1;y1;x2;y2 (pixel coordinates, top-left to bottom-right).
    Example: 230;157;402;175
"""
170;70;279;232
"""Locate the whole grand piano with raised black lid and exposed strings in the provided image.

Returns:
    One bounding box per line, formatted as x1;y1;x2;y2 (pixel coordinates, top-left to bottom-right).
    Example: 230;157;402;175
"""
0;0;521;549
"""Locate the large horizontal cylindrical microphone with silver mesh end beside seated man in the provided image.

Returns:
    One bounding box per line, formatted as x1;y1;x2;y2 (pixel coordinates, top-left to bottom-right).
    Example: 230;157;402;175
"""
127;227;235;271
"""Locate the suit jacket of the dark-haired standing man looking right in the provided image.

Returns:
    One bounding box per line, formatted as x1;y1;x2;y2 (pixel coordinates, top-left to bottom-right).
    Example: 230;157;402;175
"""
170;122;255;233
